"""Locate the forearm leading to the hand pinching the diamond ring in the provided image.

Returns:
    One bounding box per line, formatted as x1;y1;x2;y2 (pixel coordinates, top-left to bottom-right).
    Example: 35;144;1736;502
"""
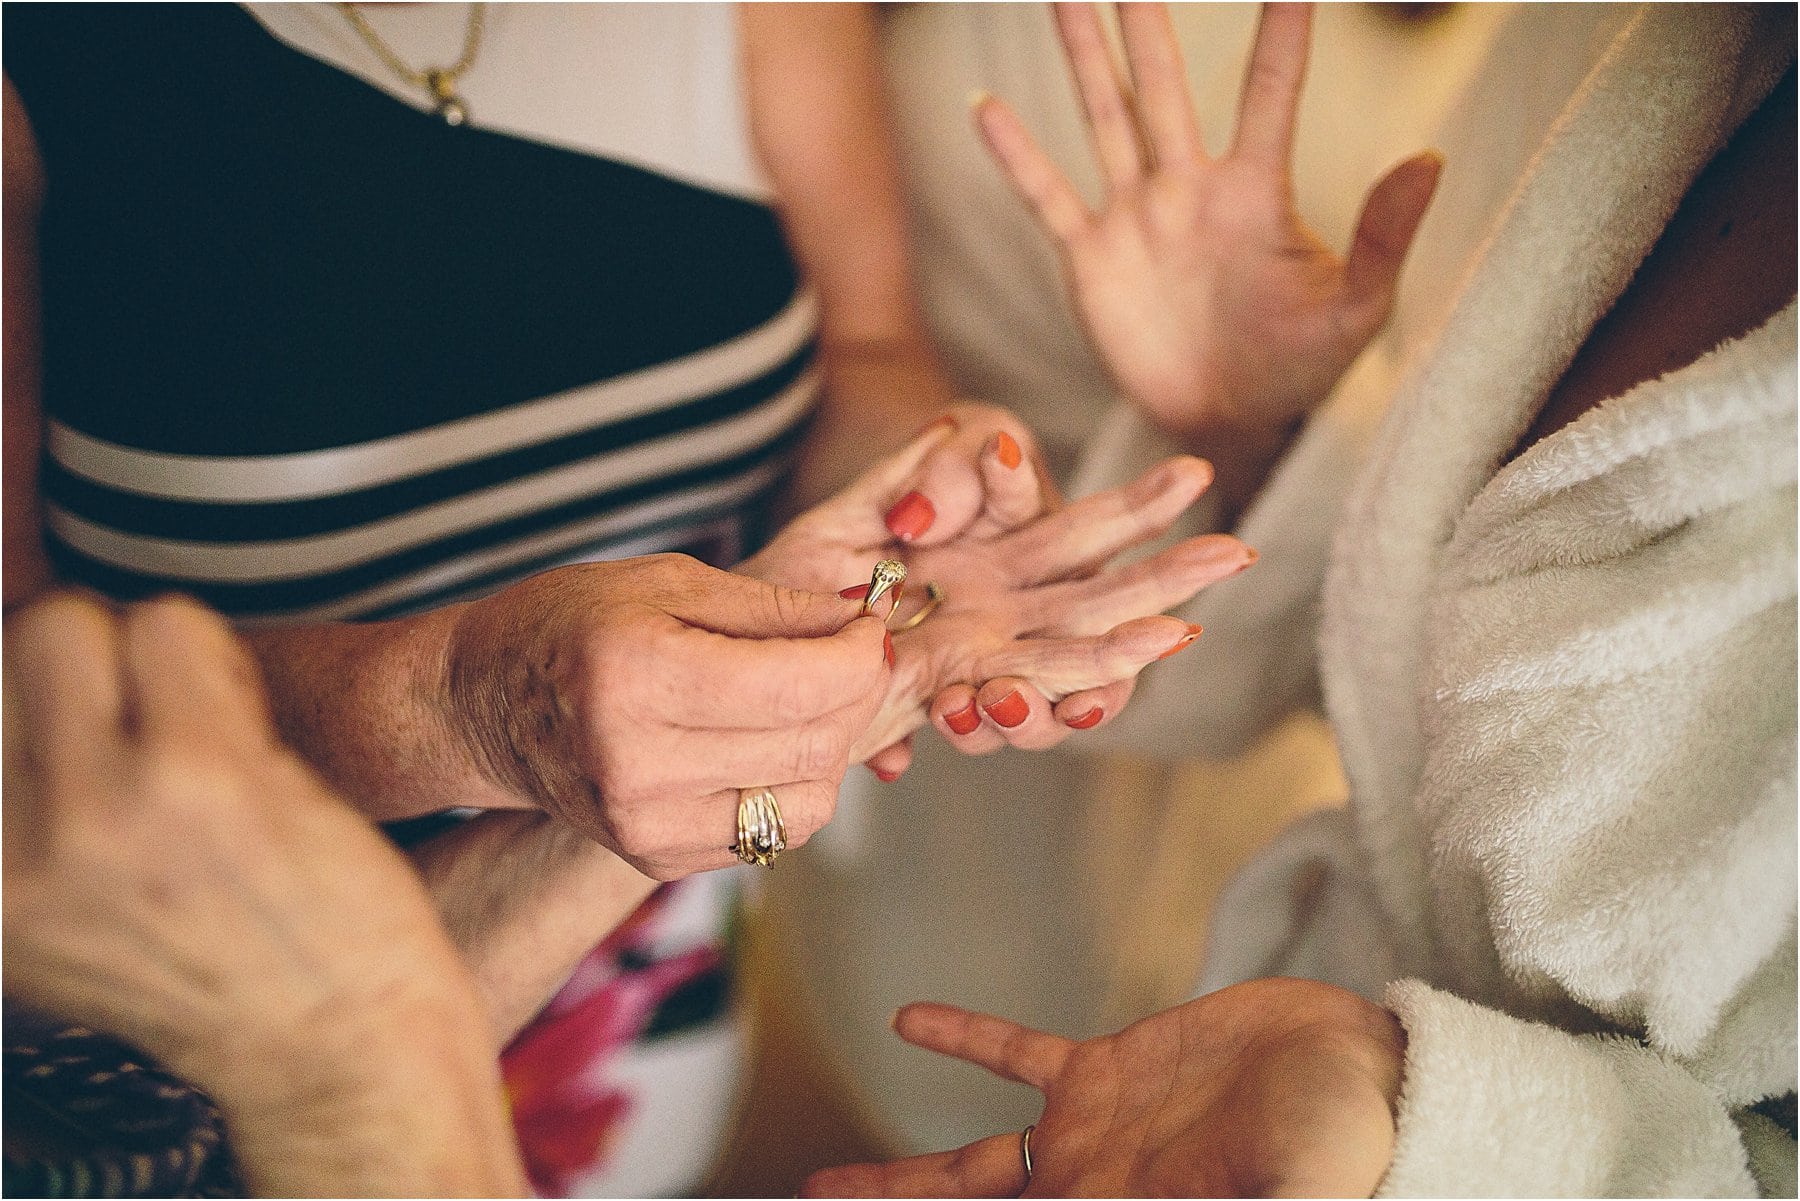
245;605;527;821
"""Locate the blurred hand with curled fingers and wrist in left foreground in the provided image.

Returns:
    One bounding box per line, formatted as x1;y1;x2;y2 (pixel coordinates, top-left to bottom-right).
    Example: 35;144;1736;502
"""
4;596;524;1196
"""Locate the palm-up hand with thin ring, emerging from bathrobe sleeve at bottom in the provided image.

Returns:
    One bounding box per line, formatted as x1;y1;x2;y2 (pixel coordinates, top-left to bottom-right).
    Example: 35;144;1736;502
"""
805;980;1406;1197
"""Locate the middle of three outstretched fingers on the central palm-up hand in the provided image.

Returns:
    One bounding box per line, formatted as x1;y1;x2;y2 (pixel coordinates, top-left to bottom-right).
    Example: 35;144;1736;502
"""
1024;533;1256;637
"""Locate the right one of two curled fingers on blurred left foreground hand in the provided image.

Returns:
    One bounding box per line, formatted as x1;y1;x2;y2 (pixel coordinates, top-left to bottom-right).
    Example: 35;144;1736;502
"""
122;596;274;747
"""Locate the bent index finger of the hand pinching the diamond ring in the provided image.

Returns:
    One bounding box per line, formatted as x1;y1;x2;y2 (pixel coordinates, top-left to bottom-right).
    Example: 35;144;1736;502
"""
666;615;887;729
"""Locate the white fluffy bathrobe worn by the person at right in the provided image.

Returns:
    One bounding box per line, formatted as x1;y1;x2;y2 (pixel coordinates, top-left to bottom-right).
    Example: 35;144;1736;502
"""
1087;5;1796;1196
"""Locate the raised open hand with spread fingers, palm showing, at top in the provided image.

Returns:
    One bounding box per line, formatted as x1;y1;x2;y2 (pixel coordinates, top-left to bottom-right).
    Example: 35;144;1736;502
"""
976;4;1440;438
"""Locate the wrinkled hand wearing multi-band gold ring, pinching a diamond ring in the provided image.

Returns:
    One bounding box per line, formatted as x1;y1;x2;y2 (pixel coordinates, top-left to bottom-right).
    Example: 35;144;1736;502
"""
446;555;887;880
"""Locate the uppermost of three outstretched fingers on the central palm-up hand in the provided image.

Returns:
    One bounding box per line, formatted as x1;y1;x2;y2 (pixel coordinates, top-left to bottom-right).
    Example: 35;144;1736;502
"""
995;456;1213;583
